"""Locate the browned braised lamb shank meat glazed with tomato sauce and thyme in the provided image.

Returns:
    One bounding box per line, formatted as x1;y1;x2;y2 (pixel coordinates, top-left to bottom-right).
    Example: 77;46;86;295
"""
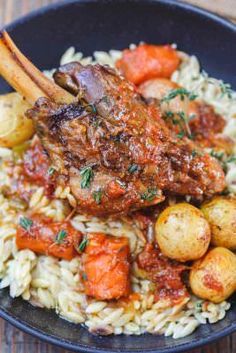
0;33;225;215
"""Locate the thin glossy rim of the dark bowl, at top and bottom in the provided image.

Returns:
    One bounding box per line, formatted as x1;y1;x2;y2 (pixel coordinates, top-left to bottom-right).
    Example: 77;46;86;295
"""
0;0;236;353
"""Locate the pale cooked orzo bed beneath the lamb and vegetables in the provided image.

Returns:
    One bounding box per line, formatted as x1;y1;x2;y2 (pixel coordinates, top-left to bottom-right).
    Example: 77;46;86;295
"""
0;48;236;338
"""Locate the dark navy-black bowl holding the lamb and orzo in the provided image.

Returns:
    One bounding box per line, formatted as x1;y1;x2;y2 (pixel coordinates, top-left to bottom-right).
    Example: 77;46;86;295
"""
0;0;236;353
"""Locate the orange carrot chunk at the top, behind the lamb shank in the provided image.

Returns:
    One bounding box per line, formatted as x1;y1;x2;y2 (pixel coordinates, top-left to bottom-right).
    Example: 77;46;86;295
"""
116;44;180;85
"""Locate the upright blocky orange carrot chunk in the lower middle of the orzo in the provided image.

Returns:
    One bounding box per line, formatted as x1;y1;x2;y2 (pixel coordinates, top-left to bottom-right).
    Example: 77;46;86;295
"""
83;233;130;300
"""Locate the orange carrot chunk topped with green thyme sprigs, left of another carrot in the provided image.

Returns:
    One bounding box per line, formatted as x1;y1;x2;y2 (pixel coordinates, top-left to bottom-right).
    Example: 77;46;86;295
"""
16;215;82;260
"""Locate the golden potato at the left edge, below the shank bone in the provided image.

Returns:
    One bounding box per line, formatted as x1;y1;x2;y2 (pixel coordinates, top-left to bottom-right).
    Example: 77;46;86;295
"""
0;92;34;147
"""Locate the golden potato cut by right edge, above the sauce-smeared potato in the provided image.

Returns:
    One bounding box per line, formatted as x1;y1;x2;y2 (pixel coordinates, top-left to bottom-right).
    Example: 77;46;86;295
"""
201;197;236;250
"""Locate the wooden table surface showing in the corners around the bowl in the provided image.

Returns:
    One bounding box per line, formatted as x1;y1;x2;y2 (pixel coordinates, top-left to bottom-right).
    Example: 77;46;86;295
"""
0;0;236;353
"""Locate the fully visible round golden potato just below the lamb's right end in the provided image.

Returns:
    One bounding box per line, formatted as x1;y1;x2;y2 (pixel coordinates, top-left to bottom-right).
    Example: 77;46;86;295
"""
155;203;211;262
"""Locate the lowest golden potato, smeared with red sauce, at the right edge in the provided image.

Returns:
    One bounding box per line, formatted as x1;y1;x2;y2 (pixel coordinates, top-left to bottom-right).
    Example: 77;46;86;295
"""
190;247;236;303
